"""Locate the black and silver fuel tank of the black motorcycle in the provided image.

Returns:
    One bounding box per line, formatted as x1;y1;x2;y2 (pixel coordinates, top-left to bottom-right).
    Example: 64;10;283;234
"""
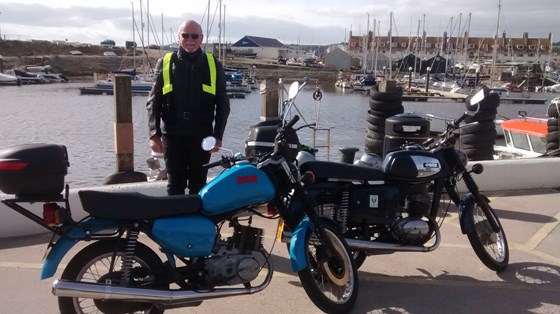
381;150;442;181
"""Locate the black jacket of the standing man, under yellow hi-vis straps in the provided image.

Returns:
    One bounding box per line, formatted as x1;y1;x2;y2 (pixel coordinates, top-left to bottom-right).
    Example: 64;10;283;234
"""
146;48;230;139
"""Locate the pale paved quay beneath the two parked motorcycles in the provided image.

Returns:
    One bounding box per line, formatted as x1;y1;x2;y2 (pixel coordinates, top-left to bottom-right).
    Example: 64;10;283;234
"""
0;189;560;314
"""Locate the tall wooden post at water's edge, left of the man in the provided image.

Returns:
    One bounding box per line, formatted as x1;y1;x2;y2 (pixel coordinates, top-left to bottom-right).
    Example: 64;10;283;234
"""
104;74;147;184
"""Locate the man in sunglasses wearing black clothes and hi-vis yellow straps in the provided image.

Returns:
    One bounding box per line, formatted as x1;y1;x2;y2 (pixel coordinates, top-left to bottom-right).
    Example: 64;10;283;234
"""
146;20;230;195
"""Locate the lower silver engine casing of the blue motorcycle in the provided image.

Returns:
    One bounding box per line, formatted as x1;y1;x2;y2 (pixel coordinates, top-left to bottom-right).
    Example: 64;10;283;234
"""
205;254;260;286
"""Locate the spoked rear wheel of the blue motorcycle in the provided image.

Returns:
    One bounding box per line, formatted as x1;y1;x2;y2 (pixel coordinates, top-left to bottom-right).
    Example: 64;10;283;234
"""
58;241;166;314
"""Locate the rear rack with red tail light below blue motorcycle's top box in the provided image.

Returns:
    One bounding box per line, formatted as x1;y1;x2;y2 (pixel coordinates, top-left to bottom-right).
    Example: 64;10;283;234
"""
1;184;73;235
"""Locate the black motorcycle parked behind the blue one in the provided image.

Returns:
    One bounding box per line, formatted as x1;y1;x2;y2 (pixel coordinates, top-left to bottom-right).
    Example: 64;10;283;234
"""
284;89;509;271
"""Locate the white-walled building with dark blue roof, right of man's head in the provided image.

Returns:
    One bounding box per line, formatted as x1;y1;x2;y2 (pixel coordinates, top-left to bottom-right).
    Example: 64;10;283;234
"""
231;35;286;59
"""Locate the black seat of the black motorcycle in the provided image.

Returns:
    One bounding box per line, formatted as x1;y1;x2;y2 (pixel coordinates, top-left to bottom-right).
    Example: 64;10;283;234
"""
300;160;385;181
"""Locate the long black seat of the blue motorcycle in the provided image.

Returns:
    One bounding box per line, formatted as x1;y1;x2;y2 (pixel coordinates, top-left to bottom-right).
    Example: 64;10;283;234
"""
78;190;202;220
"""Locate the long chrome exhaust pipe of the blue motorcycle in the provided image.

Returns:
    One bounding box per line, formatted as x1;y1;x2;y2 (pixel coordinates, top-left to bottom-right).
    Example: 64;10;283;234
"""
52;270;273;305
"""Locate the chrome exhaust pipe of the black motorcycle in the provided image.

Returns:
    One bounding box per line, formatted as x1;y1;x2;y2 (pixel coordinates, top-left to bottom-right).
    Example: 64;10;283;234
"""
282;229;441;253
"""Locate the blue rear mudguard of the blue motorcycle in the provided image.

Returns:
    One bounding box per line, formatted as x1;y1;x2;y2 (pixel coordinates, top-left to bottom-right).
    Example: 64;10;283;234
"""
41;219;117;280
